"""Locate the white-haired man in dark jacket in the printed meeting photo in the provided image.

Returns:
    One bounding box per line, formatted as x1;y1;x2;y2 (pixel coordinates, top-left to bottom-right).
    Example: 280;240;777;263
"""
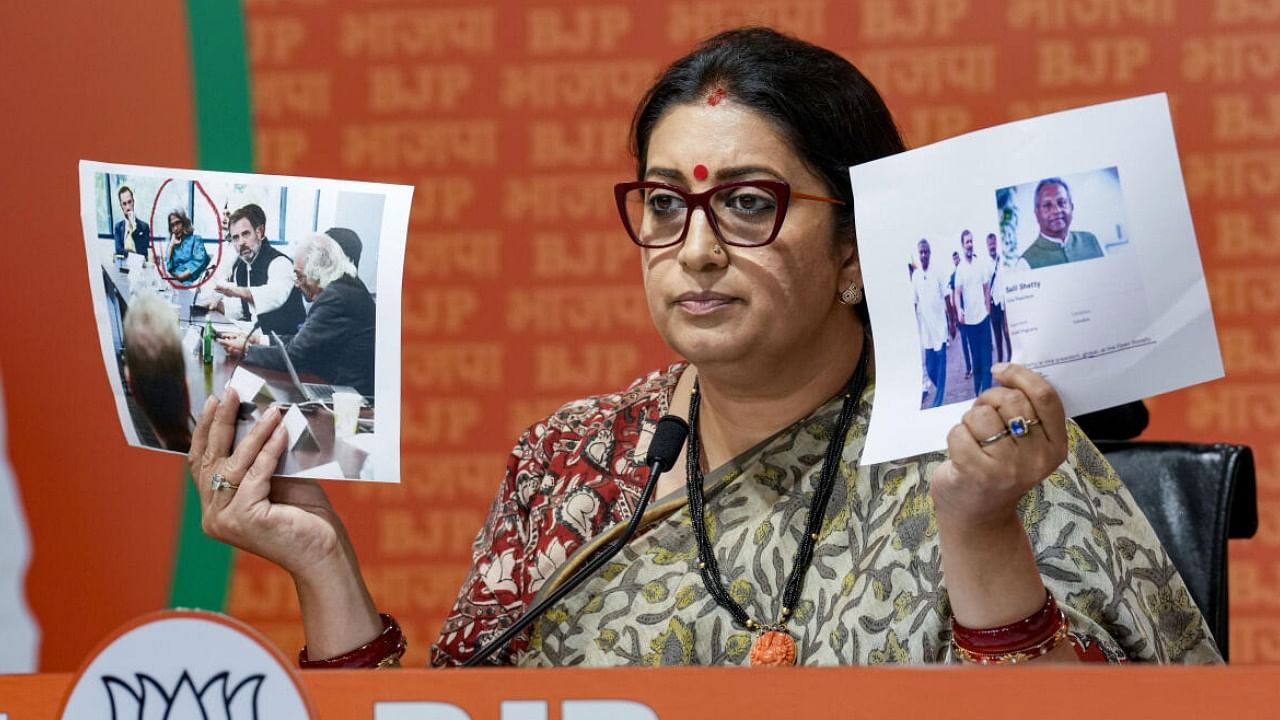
219;233;376;396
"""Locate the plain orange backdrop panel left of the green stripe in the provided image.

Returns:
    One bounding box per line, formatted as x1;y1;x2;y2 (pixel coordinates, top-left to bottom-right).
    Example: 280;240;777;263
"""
0;0;195;670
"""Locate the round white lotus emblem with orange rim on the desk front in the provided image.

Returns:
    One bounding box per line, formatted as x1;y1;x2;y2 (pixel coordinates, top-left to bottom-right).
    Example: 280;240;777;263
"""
61;610;314;720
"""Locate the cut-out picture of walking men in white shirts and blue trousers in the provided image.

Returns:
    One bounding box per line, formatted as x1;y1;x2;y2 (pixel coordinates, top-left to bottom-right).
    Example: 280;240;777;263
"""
908;229;1012;410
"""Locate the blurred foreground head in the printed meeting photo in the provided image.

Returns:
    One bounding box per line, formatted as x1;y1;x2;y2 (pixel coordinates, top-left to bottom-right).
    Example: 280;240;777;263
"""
124;295;191;452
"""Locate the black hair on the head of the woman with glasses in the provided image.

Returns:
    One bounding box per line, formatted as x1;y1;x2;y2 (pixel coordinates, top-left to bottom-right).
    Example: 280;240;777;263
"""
631;27;906;238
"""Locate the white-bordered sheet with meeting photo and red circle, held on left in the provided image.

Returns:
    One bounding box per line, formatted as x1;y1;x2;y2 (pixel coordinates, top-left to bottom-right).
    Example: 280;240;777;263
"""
81;161;411;480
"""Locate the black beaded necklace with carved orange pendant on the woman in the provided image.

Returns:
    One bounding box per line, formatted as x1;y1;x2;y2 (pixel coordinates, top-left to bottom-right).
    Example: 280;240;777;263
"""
685;337;870;665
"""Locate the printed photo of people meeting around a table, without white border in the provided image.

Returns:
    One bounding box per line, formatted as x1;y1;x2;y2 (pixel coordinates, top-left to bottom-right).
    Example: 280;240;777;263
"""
91;177;384;478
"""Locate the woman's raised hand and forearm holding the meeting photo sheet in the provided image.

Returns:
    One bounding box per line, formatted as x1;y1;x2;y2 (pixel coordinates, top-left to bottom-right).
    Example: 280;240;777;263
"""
188;388;383;660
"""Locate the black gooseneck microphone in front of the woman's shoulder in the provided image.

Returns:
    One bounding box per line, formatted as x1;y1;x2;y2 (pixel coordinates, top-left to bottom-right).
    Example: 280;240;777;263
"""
462;415;689;667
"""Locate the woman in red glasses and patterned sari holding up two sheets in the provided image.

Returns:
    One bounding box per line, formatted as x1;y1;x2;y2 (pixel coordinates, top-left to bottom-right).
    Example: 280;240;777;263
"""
191;28;1219;666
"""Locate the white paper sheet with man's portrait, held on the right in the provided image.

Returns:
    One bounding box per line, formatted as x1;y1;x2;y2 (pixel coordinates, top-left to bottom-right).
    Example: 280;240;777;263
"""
850;95;1222;464
